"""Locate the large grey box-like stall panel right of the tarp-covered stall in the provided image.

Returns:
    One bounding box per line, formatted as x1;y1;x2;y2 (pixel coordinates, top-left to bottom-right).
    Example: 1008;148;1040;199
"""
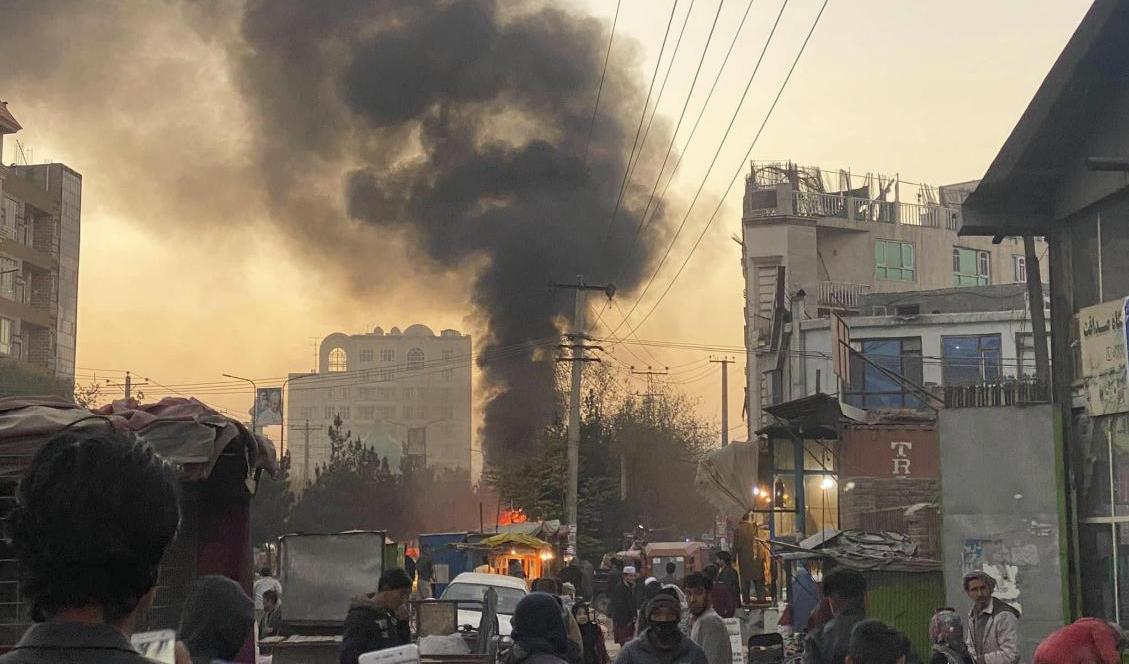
279;531;384;628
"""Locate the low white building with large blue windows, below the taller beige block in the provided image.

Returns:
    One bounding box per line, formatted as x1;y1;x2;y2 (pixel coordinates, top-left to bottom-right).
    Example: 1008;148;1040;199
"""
765;285;1035;410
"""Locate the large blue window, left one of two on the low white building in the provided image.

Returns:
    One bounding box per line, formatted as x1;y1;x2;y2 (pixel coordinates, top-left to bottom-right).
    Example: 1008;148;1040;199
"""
847;337;922;409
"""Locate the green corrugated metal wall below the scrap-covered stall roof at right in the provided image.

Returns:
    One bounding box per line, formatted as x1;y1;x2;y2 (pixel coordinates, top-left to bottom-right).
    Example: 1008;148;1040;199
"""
864;571;945;662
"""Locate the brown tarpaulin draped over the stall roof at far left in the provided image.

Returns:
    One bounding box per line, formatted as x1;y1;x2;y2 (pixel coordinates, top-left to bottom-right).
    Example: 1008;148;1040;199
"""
0;396;277;481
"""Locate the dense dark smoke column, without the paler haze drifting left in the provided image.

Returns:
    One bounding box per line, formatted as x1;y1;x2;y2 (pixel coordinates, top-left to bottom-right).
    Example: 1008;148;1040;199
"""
243;1;668;461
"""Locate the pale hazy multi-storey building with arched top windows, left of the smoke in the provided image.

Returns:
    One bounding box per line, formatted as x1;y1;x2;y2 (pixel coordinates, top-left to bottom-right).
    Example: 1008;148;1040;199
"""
286;324;472;482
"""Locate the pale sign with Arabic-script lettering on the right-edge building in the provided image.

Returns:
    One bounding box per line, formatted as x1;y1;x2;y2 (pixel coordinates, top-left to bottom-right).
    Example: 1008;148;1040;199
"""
1078;298;1129;416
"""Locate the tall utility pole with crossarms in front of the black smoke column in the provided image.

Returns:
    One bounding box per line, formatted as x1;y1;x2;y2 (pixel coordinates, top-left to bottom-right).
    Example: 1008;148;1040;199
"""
552;276;615;556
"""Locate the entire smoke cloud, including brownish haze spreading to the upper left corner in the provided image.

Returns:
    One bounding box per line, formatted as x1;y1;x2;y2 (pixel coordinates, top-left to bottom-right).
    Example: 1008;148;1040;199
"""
0;0;669;461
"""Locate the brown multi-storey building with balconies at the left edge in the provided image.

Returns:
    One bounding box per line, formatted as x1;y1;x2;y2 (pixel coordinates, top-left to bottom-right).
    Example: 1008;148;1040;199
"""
0;102;82;381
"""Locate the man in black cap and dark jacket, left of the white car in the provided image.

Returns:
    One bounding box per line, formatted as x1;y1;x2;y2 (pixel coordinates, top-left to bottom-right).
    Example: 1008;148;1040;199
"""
341;568;412;664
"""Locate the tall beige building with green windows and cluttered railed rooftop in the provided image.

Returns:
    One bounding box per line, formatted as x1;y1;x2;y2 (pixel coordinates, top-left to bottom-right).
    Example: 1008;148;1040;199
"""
742;163;1045;439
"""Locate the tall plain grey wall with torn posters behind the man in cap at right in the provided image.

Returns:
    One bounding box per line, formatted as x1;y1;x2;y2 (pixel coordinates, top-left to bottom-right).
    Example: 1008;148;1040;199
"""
938;404;1065;661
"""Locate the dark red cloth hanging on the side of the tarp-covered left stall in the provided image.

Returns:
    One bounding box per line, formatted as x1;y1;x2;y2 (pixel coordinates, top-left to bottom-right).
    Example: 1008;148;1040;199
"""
196;496;255;664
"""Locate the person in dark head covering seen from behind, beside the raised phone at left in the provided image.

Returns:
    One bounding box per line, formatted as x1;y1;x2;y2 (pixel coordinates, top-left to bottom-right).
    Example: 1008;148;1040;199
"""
180;575;255;664
